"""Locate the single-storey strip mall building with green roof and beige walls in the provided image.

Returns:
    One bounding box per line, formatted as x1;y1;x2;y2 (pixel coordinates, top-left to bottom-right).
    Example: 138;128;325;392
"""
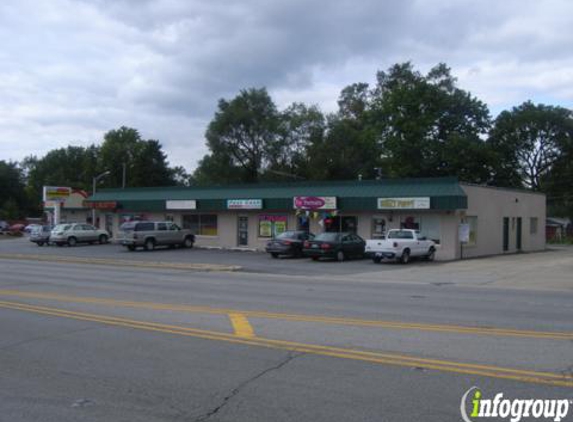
86;178;545;260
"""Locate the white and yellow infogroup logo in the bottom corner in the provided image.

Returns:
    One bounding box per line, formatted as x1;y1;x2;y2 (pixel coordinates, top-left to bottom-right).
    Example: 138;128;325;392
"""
460;386;573;422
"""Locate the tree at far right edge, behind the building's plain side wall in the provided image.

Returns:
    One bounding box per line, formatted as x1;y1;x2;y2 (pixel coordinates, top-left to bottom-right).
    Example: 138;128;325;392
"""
488;101;573;190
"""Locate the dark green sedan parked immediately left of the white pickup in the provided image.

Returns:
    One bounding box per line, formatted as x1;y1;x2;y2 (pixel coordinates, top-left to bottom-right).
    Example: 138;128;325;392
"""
302;232;366;261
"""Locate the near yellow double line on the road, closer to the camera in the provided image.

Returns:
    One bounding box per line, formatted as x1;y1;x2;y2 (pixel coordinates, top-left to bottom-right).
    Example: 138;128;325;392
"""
0;301;573;388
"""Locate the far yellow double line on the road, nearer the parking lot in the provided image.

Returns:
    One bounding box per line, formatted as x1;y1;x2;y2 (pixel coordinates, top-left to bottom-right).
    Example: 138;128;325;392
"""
0;289;573;340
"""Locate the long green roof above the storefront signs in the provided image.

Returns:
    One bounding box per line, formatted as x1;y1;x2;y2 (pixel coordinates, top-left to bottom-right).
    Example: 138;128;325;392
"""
87;178;467;211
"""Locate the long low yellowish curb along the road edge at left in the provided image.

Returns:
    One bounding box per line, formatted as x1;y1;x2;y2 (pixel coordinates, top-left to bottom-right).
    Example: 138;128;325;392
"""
0;254;243;272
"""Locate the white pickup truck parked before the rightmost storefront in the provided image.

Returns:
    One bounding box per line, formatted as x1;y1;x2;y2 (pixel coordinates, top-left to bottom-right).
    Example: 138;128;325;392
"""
364;229;436;264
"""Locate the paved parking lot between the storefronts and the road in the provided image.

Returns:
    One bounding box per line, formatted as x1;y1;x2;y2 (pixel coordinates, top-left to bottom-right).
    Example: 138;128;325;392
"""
0;237;573;291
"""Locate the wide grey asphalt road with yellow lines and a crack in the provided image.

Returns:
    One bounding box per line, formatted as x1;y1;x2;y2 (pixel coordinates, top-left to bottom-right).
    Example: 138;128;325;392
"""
0;242;573;422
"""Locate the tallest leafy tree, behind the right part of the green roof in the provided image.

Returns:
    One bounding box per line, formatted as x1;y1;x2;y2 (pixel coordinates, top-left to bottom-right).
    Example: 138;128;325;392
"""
369;63;492;183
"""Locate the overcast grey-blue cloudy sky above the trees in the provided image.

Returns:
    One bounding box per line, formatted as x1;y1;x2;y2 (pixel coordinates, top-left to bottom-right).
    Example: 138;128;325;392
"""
0;0;573;170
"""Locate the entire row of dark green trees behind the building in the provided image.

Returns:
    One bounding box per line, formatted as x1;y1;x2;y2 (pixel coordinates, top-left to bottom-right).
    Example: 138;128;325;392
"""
0;62;573;218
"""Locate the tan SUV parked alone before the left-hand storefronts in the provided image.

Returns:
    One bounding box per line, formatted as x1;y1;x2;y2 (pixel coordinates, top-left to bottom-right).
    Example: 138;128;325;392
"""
120;221;195;251
